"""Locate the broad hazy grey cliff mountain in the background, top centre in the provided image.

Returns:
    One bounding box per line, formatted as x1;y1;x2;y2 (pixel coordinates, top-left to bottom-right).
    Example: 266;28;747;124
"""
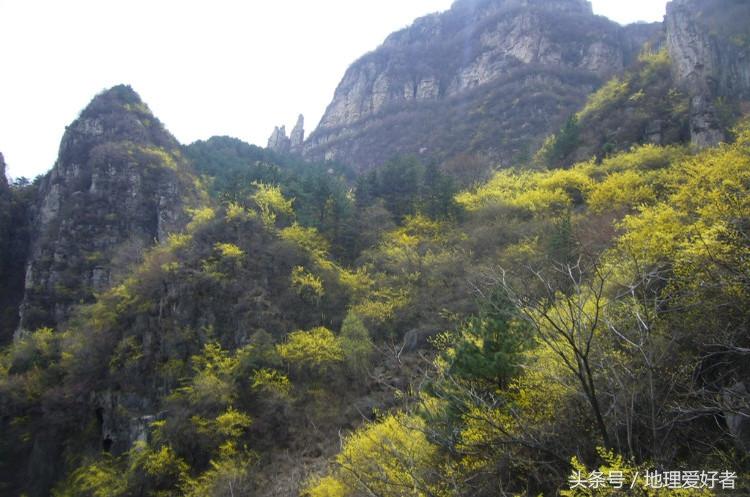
304;0;659;169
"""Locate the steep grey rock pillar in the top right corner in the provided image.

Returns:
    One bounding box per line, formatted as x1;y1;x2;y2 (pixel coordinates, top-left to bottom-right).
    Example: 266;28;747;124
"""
665;0;750;147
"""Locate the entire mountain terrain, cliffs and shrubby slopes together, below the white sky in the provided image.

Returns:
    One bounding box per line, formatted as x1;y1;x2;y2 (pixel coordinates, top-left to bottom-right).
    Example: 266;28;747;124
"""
0;0;750;497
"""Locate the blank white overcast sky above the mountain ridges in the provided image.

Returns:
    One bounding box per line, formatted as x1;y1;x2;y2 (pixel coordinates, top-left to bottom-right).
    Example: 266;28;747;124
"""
0;0;666;177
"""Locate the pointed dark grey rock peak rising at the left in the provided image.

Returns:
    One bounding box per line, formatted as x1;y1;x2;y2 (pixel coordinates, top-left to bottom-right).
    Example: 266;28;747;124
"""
19;86;196;332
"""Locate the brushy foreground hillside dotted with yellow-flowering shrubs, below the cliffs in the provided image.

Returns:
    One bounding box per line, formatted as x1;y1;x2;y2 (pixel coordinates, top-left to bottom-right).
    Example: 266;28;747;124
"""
0;102;750;496
